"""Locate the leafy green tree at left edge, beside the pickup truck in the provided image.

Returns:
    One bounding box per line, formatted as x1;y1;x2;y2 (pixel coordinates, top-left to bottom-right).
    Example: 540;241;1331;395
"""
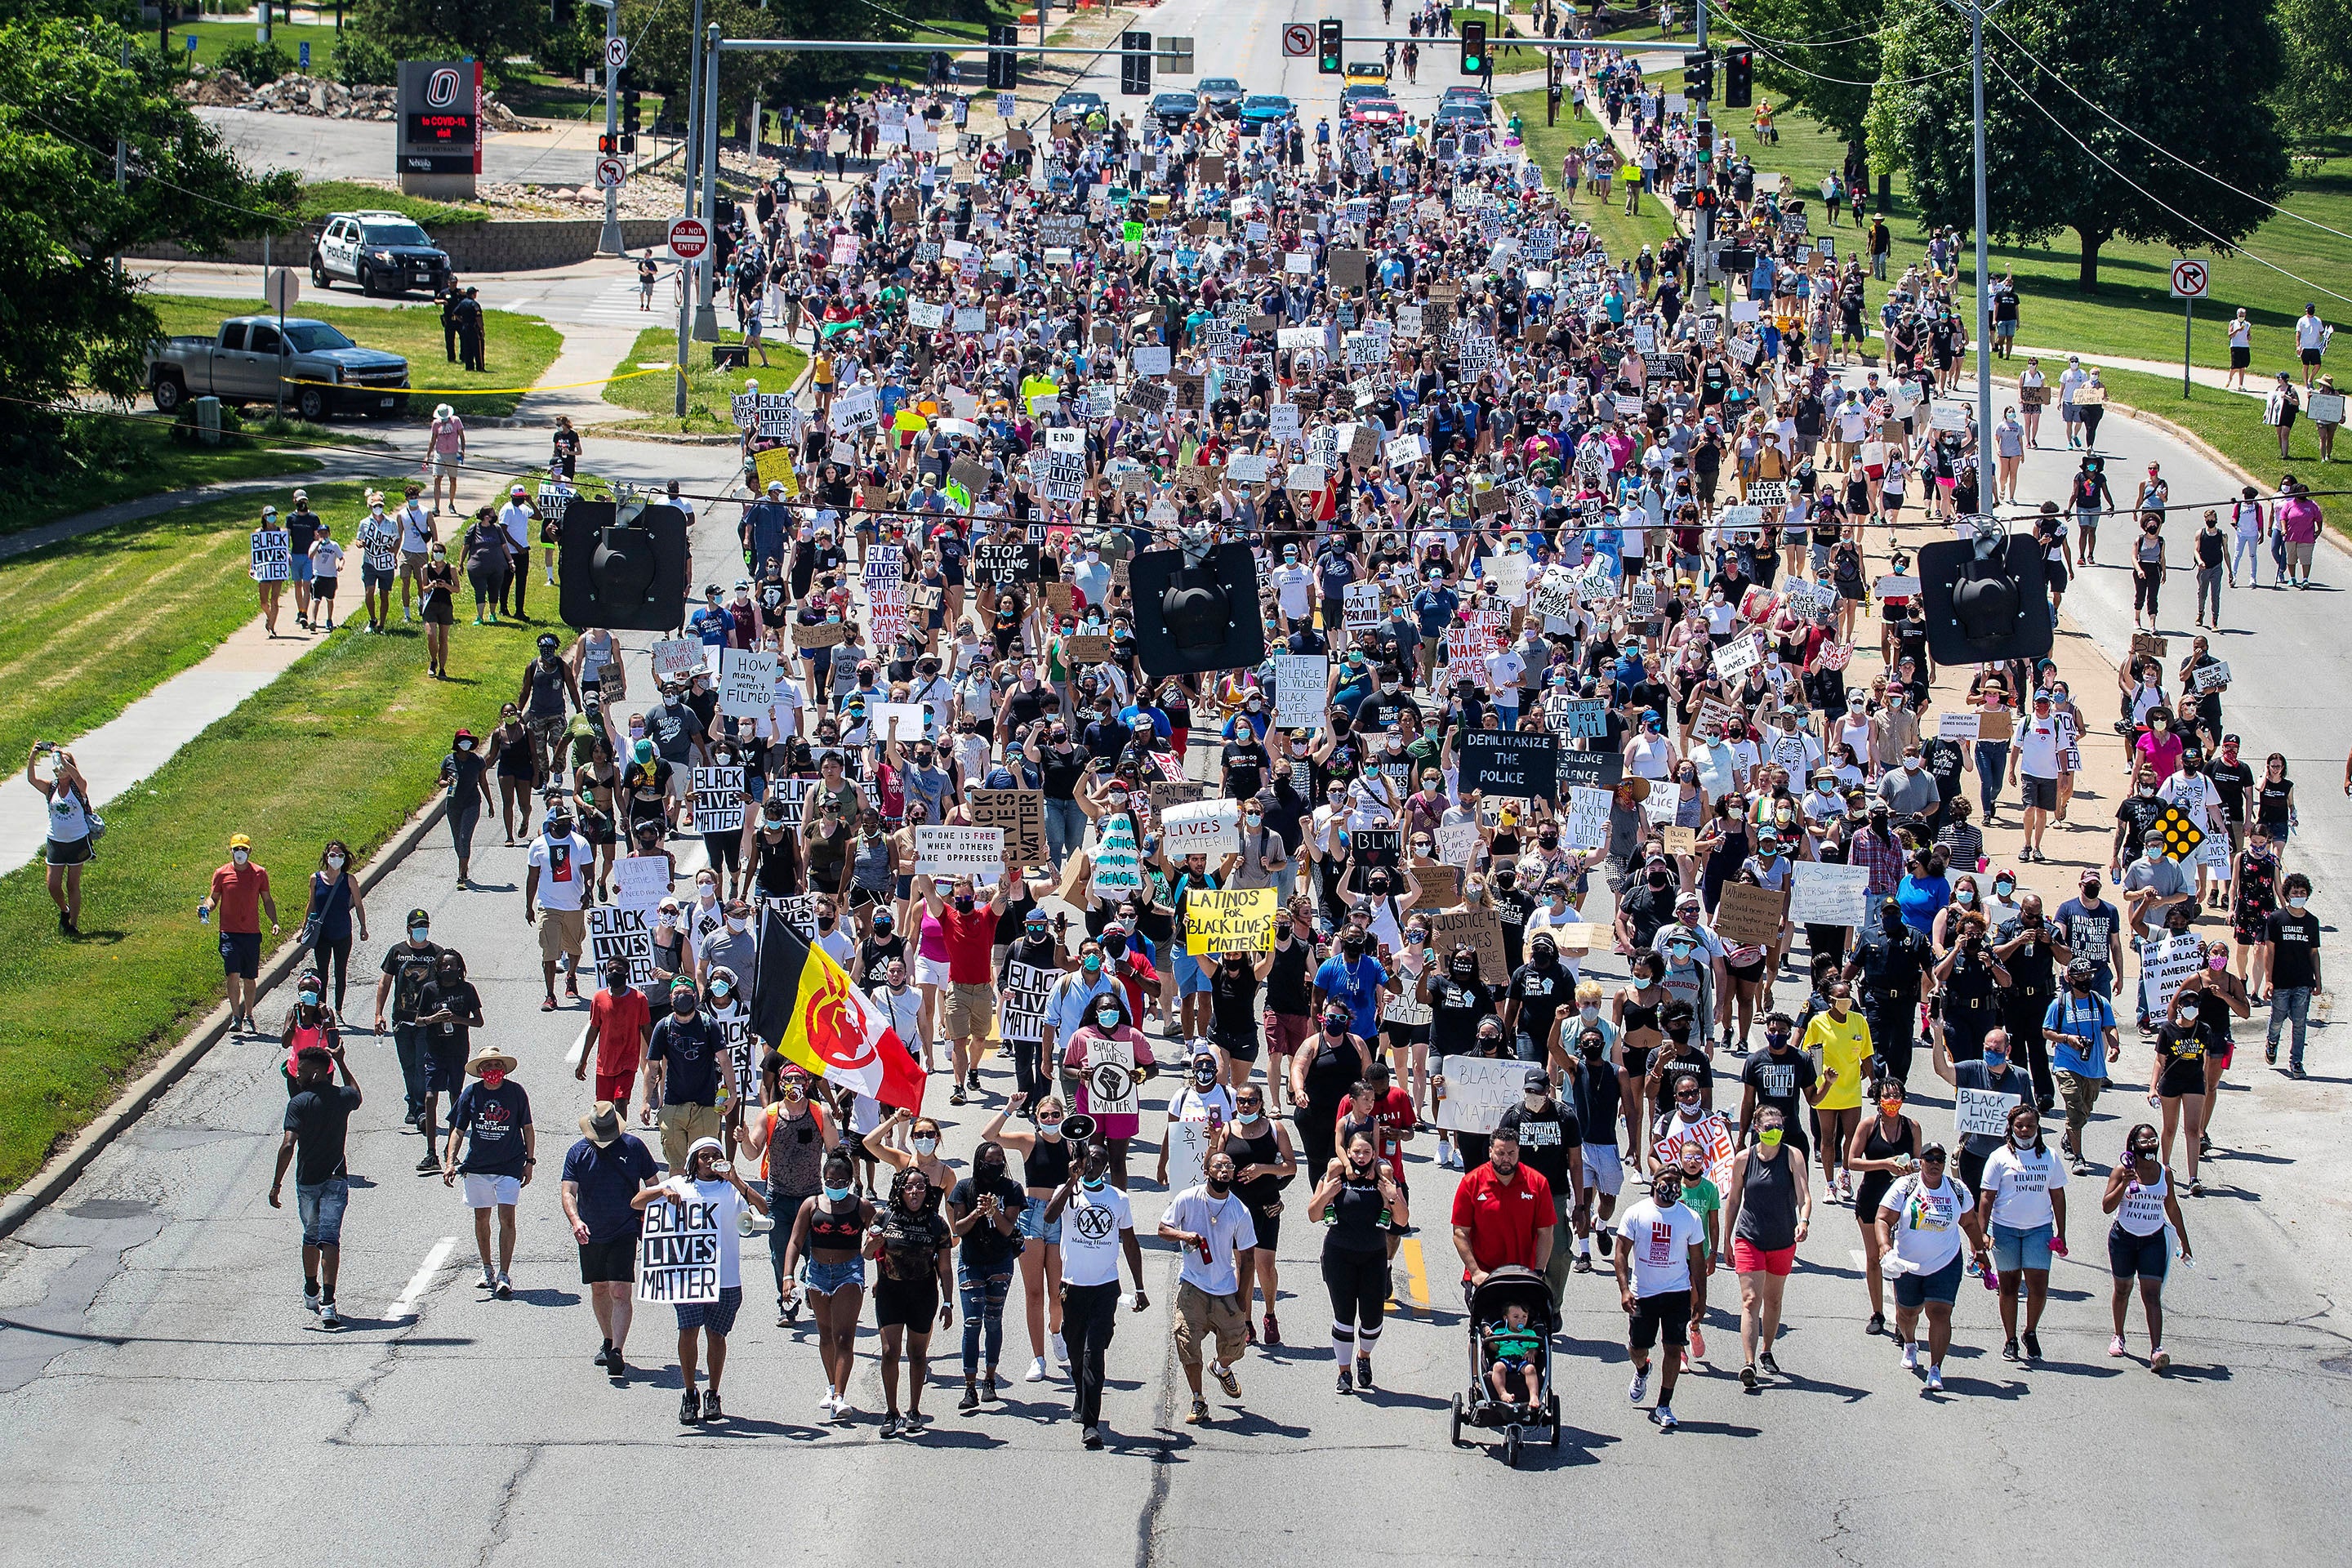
0;16;296;470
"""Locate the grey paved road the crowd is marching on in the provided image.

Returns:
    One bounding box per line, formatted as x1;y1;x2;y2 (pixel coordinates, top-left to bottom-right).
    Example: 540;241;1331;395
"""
13;0;2352;1566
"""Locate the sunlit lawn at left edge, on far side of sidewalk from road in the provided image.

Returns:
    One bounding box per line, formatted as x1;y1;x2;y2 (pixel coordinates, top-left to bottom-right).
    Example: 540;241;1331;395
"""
0;482;425;760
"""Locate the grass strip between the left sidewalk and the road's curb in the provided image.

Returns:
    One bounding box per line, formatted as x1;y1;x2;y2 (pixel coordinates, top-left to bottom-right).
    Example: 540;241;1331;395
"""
0;611;539;1190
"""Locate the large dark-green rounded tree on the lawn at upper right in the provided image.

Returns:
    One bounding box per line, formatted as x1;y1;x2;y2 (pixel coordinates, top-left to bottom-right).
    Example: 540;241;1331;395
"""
1868;0;2286;294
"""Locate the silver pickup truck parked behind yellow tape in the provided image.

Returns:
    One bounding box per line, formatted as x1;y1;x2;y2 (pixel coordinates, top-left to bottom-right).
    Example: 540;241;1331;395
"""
148;315;409;421
